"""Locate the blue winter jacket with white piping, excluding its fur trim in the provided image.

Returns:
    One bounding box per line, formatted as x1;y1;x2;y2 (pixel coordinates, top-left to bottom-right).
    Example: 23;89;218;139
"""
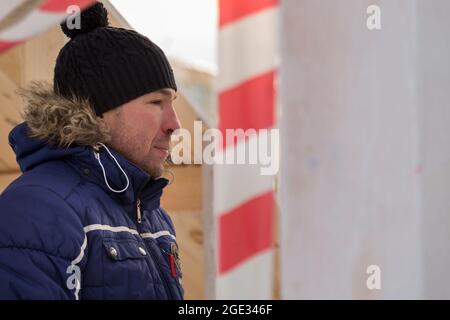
0;122;183;299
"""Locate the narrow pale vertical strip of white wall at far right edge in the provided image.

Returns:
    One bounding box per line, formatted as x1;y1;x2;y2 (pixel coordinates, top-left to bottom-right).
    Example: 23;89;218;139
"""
416;0;450;299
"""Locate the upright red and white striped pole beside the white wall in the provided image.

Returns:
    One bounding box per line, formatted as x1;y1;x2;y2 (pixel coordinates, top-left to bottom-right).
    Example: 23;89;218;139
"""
213;0;278;299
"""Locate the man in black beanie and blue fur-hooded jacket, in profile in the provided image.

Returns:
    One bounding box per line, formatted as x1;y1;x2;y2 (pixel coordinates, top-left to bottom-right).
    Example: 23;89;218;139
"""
0;3;183;299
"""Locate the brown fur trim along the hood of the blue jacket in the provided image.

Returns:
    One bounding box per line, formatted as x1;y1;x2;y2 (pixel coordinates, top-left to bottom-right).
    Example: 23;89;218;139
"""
18;82;110;148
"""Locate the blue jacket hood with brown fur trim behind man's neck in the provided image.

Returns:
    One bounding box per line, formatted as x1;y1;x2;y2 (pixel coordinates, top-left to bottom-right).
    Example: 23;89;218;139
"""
8;82;109;172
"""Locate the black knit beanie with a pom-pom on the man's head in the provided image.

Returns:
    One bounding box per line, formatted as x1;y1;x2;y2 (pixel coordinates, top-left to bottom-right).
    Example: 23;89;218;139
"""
53;2;177;115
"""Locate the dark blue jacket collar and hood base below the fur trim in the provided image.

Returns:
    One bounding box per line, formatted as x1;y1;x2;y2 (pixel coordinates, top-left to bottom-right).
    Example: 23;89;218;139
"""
9;122;168;209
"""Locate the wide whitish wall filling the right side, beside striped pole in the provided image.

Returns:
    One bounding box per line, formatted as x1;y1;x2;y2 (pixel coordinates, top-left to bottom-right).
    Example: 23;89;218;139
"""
280;0;450;299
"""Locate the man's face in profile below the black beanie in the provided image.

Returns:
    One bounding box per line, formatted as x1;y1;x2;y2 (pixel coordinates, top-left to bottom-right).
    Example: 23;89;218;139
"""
103;89;180;177
